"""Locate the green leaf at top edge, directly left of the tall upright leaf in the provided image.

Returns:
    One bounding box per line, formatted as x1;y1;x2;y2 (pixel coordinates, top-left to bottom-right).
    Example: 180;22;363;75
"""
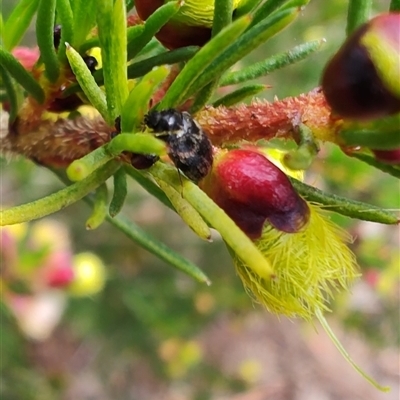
71;0;98;49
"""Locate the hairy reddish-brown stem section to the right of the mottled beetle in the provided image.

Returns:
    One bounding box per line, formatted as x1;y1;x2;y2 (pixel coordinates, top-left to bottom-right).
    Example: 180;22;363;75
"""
196;89;338;146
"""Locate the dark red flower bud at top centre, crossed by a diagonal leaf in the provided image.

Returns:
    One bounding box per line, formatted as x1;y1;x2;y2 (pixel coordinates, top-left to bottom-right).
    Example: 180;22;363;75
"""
135;0;211;49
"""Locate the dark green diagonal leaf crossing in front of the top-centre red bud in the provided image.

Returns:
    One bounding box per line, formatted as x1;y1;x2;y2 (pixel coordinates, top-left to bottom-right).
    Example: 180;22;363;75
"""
128;1;182;60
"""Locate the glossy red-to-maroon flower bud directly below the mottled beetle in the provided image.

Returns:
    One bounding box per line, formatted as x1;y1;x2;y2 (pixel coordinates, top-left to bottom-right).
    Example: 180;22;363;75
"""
201;150;309;239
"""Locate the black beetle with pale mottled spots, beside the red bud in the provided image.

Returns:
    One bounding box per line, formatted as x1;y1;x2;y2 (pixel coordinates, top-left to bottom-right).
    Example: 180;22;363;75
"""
144;109;213;182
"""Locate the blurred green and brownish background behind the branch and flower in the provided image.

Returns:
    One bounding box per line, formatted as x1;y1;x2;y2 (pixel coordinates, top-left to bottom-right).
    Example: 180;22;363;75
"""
0;0;400;400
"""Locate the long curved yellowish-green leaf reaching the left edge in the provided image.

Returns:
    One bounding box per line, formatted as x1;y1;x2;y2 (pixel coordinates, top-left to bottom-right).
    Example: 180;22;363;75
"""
0;161;120;226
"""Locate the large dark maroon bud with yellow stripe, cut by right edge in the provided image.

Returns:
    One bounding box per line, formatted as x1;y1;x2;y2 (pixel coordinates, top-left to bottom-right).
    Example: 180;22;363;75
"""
322;13;400;119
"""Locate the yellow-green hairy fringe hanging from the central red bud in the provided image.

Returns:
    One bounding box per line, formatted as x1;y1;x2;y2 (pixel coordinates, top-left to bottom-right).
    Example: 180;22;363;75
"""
235;204;359;320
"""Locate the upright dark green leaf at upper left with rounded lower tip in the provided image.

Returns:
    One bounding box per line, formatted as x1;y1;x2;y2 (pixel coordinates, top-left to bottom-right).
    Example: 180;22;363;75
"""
36;0;60;83
